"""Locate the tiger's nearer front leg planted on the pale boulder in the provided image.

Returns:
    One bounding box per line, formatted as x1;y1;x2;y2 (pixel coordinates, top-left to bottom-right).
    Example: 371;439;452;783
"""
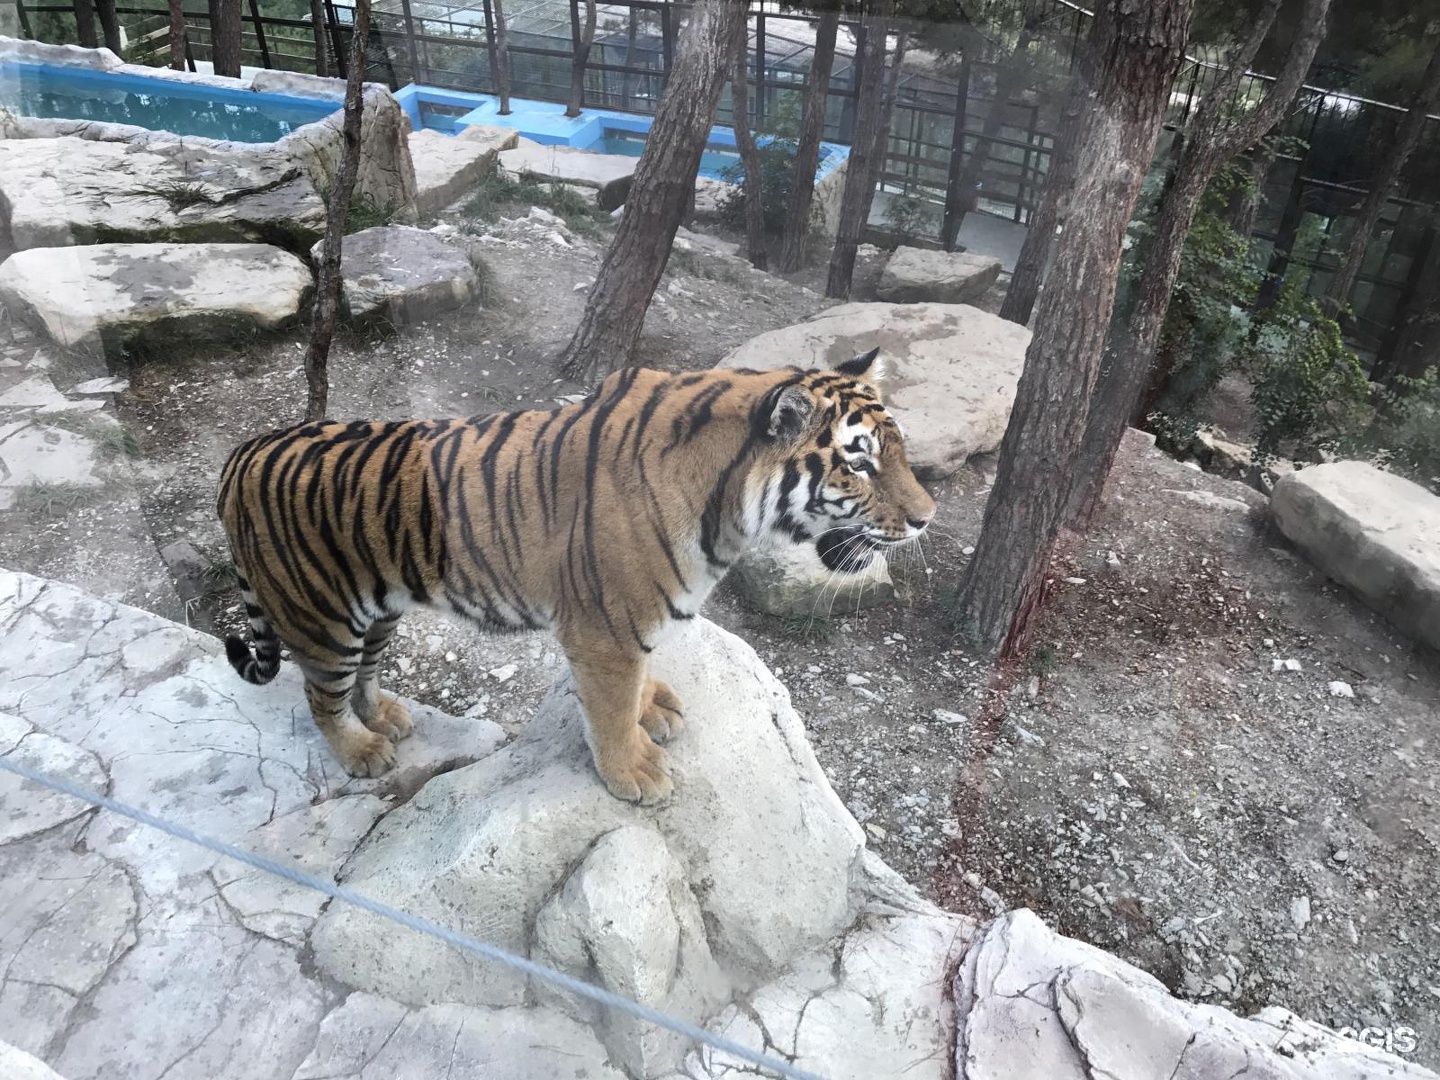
560;631;675;805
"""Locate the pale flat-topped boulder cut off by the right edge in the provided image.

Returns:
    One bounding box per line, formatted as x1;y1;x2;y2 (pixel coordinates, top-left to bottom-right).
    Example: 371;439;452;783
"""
1270;461;1440;648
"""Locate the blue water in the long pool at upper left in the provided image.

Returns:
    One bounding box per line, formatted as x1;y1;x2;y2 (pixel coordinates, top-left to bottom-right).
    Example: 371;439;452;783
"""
0;63;337;143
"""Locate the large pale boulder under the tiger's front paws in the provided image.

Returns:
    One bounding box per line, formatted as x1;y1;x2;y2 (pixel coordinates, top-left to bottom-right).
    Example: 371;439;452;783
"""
311;619;863;1068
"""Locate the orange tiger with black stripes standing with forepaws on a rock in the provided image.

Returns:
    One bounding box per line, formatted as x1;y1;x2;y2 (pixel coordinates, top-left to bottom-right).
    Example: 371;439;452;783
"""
217;350;936;804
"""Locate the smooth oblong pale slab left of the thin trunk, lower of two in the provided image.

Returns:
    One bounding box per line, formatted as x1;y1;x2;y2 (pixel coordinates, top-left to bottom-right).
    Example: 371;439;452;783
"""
0;244;312;348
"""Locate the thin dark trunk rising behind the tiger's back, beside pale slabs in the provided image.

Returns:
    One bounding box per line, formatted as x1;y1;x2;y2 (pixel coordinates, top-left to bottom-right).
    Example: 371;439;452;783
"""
305;0;370;420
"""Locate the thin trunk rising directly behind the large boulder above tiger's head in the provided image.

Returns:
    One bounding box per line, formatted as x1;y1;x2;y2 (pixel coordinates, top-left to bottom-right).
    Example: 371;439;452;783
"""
825;0;894;300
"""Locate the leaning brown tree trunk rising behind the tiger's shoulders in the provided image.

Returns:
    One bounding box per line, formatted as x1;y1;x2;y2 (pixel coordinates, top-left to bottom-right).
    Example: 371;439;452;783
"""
560;0;746;377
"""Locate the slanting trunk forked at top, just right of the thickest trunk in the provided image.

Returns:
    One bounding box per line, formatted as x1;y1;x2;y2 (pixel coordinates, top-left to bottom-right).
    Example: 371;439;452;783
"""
1067;0;1331;528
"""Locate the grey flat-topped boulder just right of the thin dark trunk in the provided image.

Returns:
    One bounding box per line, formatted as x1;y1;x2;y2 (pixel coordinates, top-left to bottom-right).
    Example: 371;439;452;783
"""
311;225;478;325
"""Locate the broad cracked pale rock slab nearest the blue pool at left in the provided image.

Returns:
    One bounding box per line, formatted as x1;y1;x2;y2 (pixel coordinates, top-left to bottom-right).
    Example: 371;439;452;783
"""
0;137;325;251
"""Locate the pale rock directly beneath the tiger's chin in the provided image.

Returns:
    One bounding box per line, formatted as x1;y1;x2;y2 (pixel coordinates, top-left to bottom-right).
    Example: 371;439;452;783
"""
729;544;896;619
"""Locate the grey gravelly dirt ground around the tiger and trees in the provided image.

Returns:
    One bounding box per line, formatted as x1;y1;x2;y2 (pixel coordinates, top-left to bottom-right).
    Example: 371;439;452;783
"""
0;198;1440;1066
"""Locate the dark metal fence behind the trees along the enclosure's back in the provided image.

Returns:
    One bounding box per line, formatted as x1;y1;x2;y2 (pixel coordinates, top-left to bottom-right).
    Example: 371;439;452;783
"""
11;0;1440;368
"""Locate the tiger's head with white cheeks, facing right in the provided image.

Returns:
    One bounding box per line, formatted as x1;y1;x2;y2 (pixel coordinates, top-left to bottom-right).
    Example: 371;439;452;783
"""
753;348;935;573
